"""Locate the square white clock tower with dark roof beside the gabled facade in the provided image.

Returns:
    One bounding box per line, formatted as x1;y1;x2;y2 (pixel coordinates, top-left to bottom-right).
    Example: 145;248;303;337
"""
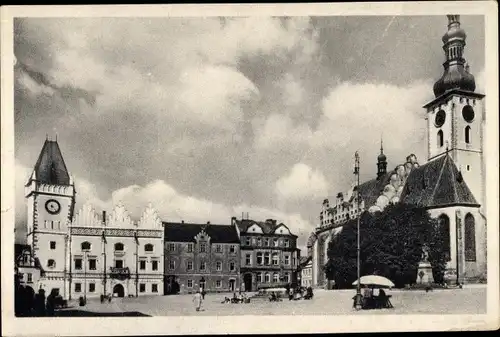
25;139;76;295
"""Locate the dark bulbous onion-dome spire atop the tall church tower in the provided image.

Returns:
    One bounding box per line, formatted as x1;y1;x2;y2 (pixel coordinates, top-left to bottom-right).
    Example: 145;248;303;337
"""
434;15;476;97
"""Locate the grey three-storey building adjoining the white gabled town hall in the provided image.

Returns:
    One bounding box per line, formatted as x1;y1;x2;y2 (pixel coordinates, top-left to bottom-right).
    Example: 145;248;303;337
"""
164;222;241;294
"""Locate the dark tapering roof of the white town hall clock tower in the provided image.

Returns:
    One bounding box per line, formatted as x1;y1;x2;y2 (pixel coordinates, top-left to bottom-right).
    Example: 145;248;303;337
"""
34;139;70;185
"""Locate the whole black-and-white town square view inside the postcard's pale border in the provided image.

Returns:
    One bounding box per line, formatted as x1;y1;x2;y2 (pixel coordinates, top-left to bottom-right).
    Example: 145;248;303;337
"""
2;2;498;331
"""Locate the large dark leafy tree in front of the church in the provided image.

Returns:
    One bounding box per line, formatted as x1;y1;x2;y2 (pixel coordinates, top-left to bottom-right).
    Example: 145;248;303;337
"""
325;203;443;288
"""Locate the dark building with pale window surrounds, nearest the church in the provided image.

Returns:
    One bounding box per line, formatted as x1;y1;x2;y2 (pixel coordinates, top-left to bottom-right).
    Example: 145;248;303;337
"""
232;217;300;291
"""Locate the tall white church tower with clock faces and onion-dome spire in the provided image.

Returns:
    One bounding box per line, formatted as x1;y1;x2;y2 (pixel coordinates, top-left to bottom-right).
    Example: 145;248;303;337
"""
424;15;485;205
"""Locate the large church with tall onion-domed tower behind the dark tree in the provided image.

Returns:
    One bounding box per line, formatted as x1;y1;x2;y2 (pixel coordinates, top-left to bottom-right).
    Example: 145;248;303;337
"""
307;15;486;287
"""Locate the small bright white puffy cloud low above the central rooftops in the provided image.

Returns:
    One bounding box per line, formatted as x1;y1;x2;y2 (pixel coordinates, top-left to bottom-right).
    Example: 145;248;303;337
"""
275;163;328;199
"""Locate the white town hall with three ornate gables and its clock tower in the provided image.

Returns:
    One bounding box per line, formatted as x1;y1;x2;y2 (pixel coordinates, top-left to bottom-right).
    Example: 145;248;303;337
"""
26;140;164;299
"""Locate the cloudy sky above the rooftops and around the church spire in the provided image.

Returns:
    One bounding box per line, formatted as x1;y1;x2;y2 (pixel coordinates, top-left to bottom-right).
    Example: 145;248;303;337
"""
14;15;484;245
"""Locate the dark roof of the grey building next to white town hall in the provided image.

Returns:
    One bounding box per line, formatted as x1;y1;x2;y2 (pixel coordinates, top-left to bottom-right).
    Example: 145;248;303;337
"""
163;222;240;243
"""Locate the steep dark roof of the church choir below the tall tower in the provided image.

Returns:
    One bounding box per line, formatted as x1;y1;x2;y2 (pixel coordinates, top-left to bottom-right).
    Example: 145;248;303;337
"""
401;154;479;208
